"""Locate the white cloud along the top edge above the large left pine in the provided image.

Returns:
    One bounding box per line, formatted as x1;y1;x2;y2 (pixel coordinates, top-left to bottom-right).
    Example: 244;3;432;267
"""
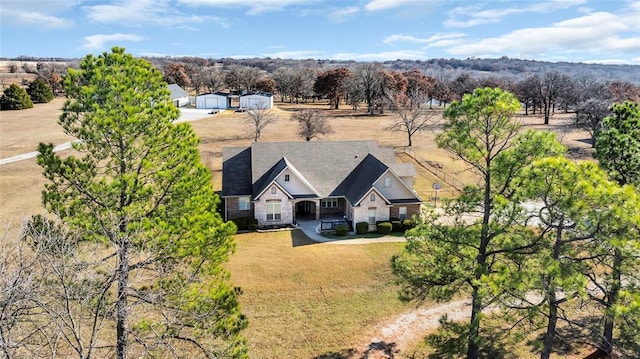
85;0;228;29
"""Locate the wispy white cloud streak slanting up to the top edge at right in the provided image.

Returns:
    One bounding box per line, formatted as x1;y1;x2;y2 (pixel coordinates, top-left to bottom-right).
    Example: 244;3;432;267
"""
444;0;586;28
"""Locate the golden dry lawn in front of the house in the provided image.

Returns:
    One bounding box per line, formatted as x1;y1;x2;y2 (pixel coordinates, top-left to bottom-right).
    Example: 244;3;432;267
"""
226;230;410;359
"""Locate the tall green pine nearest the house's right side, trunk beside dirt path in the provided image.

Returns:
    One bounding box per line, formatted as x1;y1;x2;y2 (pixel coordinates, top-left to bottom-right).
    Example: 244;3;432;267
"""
392;88;563;359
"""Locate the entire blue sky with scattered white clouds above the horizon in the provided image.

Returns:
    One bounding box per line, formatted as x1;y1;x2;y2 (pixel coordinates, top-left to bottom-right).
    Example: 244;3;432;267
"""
0;0;640;64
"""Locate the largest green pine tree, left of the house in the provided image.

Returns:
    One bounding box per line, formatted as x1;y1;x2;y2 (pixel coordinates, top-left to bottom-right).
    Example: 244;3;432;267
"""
38;47;247;358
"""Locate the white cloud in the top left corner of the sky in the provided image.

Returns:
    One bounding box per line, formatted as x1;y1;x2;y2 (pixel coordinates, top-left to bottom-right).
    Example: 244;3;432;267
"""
0;0;80;28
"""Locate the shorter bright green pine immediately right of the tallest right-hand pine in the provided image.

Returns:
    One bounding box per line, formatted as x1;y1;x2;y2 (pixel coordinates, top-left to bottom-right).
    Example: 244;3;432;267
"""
507;157;617;359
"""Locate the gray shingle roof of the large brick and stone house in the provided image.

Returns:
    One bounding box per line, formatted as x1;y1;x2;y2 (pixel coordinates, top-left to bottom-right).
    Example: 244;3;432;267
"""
222;141;419;204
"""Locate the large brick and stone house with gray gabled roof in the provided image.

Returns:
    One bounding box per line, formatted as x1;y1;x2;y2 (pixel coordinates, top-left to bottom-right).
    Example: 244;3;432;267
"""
221;141;422;230
